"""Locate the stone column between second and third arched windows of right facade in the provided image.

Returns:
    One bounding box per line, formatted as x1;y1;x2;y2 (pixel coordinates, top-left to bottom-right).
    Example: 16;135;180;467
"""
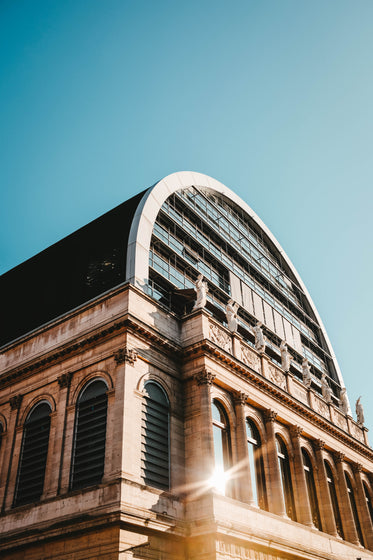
264;410;286;517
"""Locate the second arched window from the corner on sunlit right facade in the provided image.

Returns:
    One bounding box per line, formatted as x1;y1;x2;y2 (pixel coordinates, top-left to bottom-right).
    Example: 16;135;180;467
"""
246;418;267;509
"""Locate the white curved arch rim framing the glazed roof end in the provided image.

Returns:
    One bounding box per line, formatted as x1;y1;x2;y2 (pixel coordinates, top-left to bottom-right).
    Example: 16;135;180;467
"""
126;171;344;387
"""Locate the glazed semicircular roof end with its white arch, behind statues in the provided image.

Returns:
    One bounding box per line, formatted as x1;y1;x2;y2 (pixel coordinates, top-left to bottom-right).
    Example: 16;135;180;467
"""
127;172;344;403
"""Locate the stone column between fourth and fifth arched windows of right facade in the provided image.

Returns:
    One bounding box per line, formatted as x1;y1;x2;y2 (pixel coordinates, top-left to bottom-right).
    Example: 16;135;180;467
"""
314;439;338;537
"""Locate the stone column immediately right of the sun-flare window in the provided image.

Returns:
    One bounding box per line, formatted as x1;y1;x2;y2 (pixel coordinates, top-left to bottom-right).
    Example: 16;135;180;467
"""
233;393;254;504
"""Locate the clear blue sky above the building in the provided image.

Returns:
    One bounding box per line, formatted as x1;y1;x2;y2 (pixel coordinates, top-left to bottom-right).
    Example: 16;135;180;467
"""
0;0;373;430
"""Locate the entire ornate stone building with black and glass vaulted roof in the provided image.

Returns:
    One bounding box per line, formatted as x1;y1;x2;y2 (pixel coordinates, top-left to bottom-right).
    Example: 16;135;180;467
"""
0;172;373;560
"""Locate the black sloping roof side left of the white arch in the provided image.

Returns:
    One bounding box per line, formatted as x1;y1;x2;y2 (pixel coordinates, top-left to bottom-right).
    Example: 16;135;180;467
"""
0;191;145;346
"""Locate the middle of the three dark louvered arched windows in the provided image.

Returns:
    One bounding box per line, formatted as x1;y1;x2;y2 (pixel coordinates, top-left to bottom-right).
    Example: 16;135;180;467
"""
70;379;107;490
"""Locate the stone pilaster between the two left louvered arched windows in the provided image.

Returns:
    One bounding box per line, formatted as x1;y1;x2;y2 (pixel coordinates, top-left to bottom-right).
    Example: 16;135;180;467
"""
43;372;73;498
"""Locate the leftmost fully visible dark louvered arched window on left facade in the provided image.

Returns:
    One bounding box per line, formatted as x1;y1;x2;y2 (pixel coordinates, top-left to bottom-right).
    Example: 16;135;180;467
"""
14;401;52;506
